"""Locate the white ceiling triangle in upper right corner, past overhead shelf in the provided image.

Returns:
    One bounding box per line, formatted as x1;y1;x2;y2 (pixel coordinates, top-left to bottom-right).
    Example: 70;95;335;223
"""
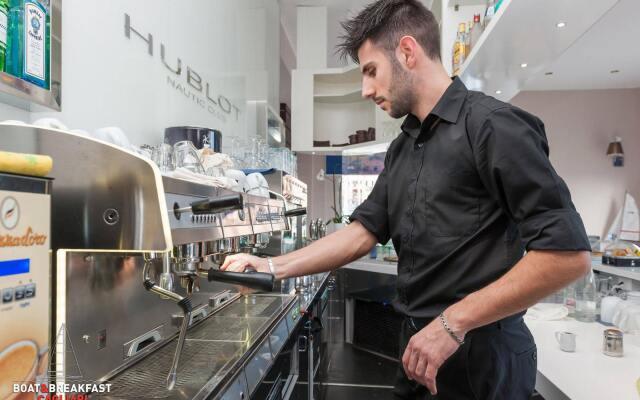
524;0;640;90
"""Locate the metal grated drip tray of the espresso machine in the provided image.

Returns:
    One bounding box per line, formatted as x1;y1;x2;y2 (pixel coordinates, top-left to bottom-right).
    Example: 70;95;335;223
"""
91;295;294;399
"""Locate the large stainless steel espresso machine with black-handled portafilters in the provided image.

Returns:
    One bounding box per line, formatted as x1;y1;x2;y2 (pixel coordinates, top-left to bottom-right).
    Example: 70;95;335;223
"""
0;124;300;399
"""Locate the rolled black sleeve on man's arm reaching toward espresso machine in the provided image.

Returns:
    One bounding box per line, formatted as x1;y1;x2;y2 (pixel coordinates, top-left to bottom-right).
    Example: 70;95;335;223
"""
349;151;391;244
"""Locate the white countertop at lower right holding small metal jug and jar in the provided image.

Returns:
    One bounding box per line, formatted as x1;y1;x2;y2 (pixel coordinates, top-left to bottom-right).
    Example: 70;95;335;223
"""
525;318;640;400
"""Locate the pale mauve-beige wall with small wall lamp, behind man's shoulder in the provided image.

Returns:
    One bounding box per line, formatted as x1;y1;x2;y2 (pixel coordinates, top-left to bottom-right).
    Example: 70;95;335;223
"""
512;89;640;236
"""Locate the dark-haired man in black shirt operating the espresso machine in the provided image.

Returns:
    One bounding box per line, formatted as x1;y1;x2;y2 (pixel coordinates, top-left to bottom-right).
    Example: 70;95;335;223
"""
221;0;590;399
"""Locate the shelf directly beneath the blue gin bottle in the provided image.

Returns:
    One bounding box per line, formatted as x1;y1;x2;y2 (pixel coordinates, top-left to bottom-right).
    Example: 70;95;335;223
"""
0;72;60;111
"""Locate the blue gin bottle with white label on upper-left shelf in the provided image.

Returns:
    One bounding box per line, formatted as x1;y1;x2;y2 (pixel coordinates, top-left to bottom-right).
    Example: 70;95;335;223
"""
7;0;49;89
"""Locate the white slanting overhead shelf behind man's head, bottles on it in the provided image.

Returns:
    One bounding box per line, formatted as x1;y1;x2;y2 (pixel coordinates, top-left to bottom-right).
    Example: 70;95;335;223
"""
456;0;619;101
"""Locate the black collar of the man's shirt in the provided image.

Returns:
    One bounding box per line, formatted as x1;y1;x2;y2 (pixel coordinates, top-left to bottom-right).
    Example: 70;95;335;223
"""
402;77;468;139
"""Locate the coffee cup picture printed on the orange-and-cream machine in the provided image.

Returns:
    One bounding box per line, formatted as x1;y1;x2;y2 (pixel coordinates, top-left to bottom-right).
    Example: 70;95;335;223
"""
0;340;48;400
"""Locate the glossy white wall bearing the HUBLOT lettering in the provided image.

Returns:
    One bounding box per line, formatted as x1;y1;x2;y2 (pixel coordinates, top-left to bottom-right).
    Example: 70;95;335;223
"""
0;0;280;148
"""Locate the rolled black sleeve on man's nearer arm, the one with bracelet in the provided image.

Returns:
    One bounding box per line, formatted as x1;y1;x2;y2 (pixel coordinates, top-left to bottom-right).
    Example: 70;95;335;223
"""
473;106;591;251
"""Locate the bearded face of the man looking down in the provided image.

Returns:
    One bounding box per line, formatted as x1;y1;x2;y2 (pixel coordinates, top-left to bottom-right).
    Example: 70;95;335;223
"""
358;40;415;118
